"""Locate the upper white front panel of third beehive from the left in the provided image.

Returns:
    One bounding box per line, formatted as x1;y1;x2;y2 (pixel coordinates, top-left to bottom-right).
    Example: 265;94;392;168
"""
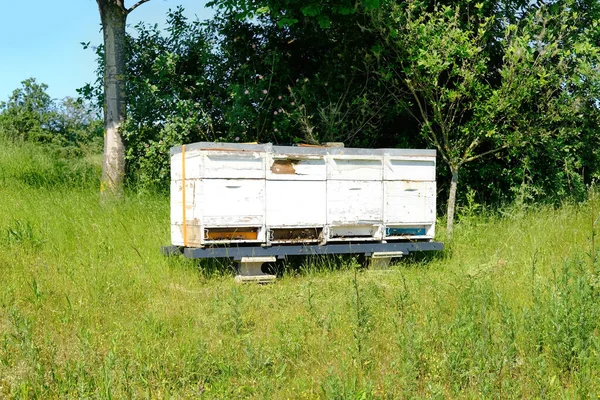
327;154;383;181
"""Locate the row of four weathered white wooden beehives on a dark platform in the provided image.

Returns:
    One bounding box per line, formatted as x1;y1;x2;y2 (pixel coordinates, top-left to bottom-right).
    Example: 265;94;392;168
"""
171;142;436;247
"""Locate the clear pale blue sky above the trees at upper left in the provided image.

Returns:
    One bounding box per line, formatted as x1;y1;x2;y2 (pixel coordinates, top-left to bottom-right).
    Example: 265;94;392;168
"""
0;0;214;101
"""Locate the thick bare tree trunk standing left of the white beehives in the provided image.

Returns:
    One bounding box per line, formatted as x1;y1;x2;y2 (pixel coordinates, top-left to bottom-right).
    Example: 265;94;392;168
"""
97;0;127;195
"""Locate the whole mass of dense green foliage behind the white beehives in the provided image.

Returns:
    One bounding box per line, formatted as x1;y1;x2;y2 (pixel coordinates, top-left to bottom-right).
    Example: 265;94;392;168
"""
80;0;600;209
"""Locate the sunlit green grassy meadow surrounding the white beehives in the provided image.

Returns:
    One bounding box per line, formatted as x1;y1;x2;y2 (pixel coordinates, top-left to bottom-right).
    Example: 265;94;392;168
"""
0;138;600;399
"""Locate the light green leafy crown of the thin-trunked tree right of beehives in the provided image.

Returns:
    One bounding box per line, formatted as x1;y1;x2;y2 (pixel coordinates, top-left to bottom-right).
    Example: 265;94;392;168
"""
386;3;598;167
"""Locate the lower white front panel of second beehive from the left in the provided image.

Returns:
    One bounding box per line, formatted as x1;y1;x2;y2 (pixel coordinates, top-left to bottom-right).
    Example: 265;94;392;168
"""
266;180;327;228
